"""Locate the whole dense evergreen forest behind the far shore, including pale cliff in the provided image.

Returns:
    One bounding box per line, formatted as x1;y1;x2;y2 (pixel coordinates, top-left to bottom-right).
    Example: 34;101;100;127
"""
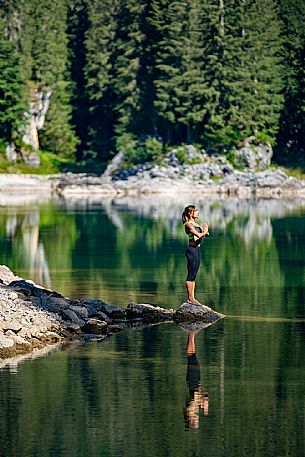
0;0;305;167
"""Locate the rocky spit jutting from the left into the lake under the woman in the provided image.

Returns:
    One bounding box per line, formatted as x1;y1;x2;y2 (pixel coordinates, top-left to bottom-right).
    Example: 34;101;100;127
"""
0;265;224;359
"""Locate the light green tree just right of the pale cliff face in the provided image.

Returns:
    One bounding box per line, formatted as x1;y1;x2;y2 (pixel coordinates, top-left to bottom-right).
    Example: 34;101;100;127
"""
31;0;78;157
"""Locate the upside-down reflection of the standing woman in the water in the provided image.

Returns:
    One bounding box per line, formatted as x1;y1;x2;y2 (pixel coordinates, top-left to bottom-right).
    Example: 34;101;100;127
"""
184;328;209;429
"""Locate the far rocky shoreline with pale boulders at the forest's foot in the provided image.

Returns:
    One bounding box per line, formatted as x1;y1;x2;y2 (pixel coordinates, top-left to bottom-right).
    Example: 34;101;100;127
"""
0;145;305;197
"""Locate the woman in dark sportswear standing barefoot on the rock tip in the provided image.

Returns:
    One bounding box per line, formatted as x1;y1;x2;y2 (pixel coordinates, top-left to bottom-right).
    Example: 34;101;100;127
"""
182;205;209;305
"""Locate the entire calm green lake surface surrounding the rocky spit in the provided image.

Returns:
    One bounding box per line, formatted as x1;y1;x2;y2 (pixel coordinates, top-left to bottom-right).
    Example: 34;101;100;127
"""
0;197;305;457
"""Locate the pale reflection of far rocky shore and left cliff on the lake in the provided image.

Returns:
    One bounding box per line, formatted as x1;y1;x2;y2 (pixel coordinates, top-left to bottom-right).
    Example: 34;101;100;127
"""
0;194;305;251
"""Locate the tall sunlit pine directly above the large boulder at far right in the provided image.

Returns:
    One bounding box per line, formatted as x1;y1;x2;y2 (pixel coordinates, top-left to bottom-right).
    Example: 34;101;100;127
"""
239;0;283;142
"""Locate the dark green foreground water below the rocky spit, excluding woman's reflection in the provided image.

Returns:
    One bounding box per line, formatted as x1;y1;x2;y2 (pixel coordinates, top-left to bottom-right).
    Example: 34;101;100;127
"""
0;319;305;457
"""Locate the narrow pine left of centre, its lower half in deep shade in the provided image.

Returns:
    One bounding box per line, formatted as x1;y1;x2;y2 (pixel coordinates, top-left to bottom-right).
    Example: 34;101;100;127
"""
84;0;119;160
